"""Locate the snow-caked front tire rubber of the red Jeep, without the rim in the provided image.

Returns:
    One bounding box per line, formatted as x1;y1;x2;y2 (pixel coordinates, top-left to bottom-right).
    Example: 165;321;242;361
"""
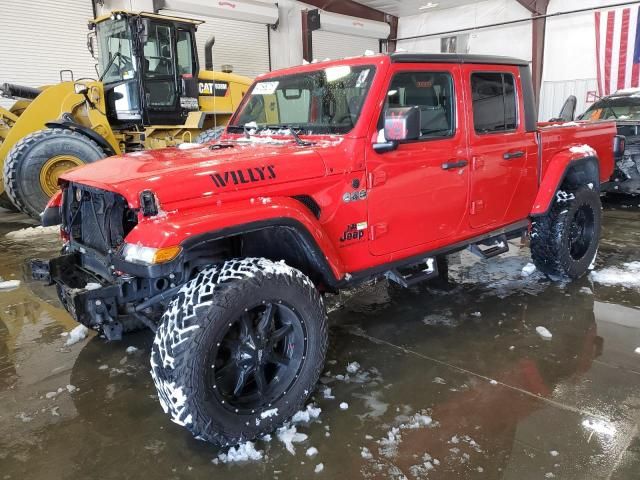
151;258;327;446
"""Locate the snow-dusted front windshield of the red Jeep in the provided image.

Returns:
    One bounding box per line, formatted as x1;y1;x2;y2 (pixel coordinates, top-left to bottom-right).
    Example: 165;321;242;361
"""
229;65;375;135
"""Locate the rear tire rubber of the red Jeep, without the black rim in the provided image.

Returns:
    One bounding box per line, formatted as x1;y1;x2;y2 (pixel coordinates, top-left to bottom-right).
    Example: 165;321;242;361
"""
531;187;602;279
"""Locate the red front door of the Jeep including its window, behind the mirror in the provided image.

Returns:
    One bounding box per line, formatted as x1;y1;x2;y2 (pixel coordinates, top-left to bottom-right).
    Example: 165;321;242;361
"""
367;64;469;255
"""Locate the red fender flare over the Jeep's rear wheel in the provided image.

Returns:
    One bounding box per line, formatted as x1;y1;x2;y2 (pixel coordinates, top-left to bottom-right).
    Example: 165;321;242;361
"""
530;149;600;217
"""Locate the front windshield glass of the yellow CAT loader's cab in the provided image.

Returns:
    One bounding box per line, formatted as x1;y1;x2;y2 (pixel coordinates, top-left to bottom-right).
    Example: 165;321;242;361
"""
96;18;135;83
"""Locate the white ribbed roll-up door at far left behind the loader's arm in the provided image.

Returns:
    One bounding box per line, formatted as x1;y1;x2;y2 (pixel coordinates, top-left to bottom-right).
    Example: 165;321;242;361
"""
0;0;96;107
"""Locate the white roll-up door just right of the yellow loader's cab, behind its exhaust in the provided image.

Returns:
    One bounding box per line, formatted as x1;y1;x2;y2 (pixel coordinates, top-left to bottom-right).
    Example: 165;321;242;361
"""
162;10;269;78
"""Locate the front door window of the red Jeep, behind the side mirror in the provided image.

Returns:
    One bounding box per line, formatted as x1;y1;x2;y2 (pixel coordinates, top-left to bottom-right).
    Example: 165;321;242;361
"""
386;72;456;140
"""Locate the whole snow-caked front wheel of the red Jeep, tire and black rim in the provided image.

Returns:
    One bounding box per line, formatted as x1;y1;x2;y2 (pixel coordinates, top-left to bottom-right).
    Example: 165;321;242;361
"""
151;258;327;446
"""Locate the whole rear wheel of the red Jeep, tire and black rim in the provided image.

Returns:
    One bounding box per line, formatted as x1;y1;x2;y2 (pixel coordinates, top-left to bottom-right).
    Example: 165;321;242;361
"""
531;187;602;279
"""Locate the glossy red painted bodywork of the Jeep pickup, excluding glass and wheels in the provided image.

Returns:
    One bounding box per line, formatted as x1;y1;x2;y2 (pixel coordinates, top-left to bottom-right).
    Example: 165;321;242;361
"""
63;55;616;279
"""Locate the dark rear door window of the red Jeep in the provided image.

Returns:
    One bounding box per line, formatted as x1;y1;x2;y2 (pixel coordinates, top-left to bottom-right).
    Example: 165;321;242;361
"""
471;72;518;134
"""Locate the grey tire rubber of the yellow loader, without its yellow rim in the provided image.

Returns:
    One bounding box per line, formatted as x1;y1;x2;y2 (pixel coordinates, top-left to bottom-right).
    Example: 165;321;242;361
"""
4;128;107;220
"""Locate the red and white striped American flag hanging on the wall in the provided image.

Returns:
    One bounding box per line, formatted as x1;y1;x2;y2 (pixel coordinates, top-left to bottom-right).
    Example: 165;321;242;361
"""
595;5;640;96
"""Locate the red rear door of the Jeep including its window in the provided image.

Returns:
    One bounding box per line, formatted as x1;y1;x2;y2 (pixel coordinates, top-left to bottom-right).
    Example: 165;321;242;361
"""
462;65;537;230
